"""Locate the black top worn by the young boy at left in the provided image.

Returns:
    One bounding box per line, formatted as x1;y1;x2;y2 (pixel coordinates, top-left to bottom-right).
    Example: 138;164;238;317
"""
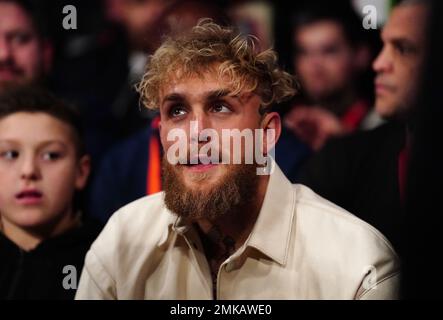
0;221;101;300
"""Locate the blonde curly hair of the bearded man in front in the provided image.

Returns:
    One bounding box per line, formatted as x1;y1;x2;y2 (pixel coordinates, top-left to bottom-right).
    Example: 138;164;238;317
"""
136;19;298;112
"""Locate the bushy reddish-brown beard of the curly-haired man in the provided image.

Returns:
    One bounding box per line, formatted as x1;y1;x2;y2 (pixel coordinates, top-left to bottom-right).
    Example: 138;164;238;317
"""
162;157;259;221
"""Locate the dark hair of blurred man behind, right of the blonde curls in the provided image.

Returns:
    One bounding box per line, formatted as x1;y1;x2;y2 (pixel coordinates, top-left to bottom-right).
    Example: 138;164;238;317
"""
292;1;364;46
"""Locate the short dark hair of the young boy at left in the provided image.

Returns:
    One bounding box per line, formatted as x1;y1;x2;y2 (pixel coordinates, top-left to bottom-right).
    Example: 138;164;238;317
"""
0;86;85;157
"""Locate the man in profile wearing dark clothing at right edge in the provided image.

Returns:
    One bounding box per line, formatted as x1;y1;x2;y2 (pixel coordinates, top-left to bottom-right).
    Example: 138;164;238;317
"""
300;1;428;254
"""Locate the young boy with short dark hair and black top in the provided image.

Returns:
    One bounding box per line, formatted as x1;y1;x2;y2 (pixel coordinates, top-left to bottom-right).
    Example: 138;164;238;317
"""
0;87;100;299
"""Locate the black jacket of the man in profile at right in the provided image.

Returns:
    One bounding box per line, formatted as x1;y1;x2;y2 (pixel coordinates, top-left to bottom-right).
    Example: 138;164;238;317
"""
300;122;406;251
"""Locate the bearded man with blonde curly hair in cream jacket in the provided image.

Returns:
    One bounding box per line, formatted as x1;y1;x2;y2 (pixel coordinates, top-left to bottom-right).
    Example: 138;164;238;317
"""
77;20;399;299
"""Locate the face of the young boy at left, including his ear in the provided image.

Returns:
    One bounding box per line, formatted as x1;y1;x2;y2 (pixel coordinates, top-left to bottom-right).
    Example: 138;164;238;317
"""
0;112;89;230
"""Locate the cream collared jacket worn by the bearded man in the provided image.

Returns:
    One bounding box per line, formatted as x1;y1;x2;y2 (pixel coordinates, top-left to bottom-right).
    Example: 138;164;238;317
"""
76;167;399;299
